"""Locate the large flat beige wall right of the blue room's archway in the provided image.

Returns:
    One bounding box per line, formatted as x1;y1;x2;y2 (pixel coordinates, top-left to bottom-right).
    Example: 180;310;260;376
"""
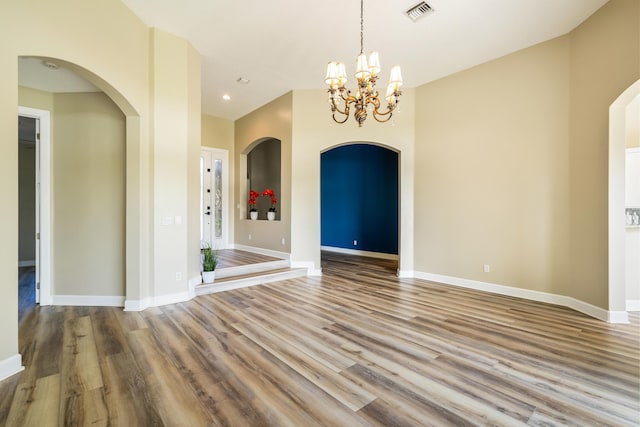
415;37;570;294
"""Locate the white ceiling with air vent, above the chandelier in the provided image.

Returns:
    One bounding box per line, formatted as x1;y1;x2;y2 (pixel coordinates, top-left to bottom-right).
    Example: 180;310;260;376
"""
20;0;607;120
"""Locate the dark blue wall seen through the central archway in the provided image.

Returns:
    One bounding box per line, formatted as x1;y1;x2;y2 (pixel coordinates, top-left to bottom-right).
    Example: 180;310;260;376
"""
320;144;398;254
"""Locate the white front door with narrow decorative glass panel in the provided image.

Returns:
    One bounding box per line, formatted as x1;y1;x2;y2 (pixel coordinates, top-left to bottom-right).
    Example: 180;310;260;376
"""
200;147;229;249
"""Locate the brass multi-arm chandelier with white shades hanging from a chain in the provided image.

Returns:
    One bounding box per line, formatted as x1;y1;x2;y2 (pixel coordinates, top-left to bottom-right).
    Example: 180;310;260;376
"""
324;0;402;127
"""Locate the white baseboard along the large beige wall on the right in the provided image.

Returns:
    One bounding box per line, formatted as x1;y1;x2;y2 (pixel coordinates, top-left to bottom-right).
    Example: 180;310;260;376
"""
414;272;629;323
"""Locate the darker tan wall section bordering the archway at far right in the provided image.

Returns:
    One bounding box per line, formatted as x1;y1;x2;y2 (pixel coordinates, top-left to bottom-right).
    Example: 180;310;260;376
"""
559;0;640;310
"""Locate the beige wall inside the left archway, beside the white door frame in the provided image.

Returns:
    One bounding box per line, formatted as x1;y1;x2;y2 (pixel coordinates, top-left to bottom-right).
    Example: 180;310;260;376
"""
51;92;125;296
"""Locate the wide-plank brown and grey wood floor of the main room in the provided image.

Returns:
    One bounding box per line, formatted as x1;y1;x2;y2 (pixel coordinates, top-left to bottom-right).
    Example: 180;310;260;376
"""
0;254;640;426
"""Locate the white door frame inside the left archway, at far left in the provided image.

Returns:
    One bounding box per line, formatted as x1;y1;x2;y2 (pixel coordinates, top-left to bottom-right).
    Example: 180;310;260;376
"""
18;106;53;305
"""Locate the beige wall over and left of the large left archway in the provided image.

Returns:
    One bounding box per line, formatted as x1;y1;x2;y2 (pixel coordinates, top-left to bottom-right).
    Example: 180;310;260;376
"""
0;0;149;361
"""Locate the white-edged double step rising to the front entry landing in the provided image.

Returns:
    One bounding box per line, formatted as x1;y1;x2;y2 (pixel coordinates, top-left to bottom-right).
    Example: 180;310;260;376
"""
195;260;307;295
